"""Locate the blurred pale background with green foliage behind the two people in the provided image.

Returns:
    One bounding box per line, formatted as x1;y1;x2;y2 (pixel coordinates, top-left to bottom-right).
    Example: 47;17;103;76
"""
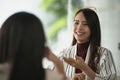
0;0;120;80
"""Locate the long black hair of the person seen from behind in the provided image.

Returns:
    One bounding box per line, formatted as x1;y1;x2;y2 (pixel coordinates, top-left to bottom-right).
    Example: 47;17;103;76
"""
0;12;46;80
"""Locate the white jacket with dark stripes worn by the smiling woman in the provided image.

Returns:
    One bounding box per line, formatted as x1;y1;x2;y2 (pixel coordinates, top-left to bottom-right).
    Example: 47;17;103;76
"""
46;45;117;80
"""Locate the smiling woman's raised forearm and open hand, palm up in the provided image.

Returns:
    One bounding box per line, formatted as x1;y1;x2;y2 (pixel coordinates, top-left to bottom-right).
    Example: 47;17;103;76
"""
63;56;95;80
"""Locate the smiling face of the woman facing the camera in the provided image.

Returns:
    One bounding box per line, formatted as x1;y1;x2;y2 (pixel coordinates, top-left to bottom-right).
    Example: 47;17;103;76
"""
73;12;91;44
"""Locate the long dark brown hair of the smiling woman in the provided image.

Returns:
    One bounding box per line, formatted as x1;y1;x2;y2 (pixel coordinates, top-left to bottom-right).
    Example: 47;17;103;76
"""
72;8;101;72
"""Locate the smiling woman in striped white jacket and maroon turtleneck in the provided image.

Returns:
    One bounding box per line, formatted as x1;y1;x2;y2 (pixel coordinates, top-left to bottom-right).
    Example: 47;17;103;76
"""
57;8;116;80
